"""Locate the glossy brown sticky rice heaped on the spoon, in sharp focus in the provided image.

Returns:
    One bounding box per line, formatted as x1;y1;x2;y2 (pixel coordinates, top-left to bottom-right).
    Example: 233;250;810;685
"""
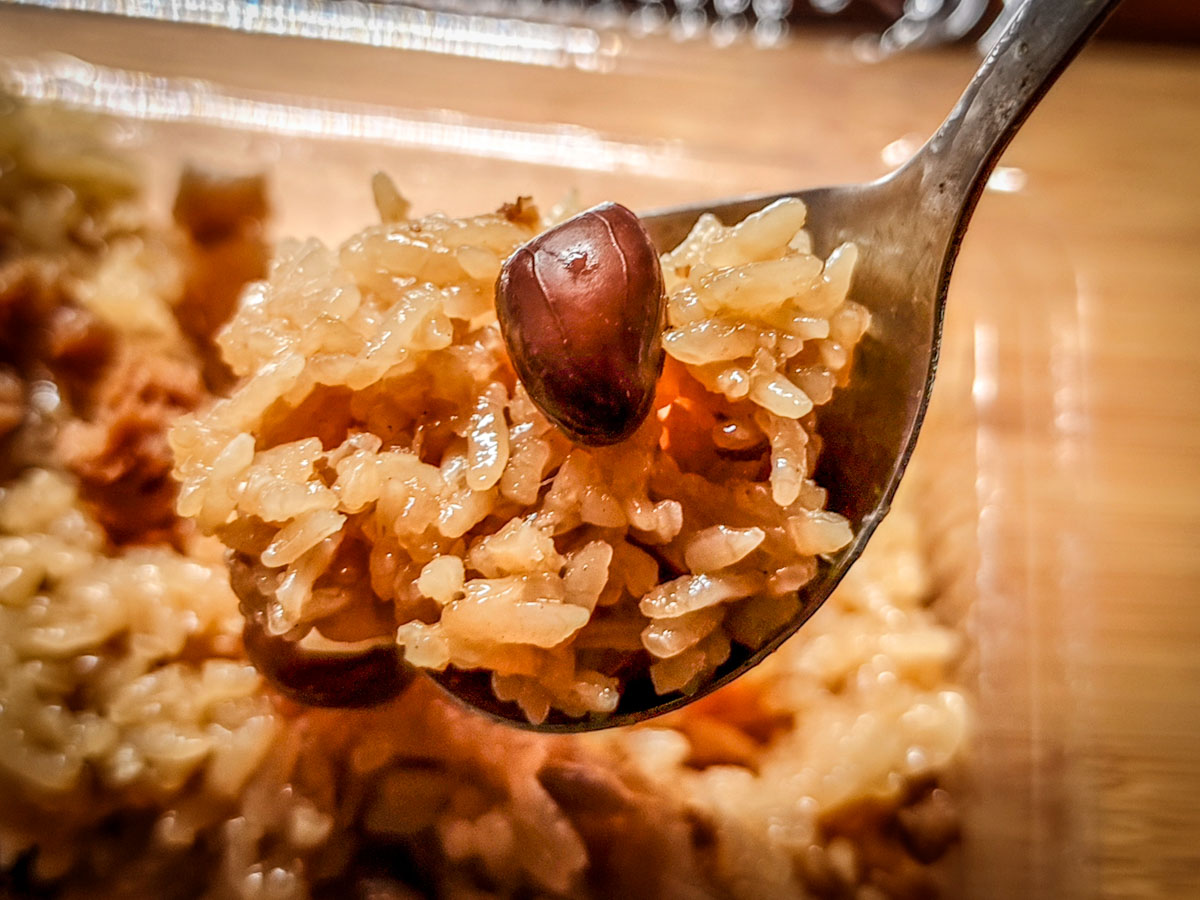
170;181;868;721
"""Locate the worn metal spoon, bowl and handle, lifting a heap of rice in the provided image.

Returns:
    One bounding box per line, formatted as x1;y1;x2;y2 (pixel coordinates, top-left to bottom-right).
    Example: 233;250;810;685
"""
400;0;1120;732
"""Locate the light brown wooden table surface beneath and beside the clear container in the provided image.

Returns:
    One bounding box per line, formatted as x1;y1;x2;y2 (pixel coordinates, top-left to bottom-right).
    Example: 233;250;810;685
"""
0;7;1200;898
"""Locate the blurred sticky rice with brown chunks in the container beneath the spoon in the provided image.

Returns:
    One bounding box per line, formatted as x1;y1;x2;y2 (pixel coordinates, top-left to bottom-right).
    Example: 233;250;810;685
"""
0;97;970;900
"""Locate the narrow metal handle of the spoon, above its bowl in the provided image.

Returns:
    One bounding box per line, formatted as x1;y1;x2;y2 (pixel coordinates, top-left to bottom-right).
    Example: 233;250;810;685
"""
905;0;1121;225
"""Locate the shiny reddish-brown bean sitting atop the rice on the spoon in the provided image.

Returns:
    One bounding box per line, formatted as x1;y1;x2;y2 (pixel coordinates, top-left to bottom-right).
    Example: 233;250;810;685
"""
496;203;666;444
